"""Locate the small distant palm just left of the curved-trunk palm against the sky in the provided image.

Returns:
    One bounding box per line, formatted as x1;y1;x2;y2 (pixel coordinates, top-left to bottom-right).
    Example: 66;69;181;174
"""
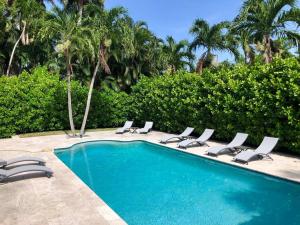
163;36;194;74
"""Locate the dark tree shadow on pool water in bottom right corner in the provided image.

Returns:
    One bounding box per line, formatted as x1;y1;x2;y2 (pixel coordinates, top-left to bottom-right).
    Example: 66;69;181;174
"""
223;185;300;225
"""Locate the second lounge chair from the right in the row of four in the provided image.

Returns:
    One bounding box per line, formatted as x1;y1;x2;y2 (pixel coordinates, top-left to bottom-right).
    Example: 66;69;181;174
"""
206;133;248;156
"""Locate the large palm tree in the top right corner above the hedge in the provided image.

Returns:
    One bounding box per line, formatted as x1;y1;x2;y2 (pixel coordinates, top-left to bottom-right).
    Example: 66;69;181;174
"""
235;0;300;63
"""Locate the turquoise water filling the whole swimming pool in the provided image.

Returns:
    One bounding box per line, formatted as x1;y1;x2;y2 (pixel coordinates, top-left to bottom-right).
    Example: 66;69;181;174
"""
56;141;300;225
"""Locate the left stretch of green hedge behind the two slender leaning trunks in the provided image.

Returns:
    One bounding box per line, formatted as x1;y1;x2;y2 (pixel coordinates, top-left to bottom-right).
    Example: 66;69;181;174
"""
0;68;130;137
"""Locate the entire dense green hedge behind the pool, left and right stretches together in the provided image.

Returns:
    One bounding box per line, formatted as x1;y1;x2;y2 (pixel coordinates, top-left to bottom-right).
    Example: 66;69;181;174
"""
0;58;300;153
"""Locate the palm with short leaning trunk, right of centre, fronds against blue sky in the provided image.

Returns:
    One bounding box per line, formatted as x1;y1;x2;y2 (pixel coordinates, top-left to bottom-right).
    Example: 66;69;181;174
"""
190;19;239;74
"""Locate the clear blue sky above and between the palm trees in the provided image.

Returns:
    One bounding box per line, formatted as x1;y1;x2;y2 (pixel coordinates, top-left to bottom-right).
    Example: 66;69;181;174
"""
105;0;243;61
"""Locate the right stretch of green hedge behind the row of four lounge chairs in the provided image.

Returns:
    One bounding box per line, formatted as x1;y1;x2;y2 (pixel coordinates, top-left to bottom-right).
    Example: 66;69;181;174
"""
131;59;300;153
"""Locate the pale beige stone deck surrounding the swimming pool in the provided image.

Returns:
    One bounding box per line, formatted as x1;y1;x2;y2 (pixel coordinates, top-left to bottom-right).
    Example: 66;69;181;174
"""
0;131;300;225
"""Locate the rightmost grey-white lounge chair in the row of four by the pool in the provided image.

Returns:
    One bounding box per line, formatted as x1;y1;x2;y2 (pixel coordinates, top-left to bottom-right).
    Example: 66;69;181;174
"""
233;137;279;164
